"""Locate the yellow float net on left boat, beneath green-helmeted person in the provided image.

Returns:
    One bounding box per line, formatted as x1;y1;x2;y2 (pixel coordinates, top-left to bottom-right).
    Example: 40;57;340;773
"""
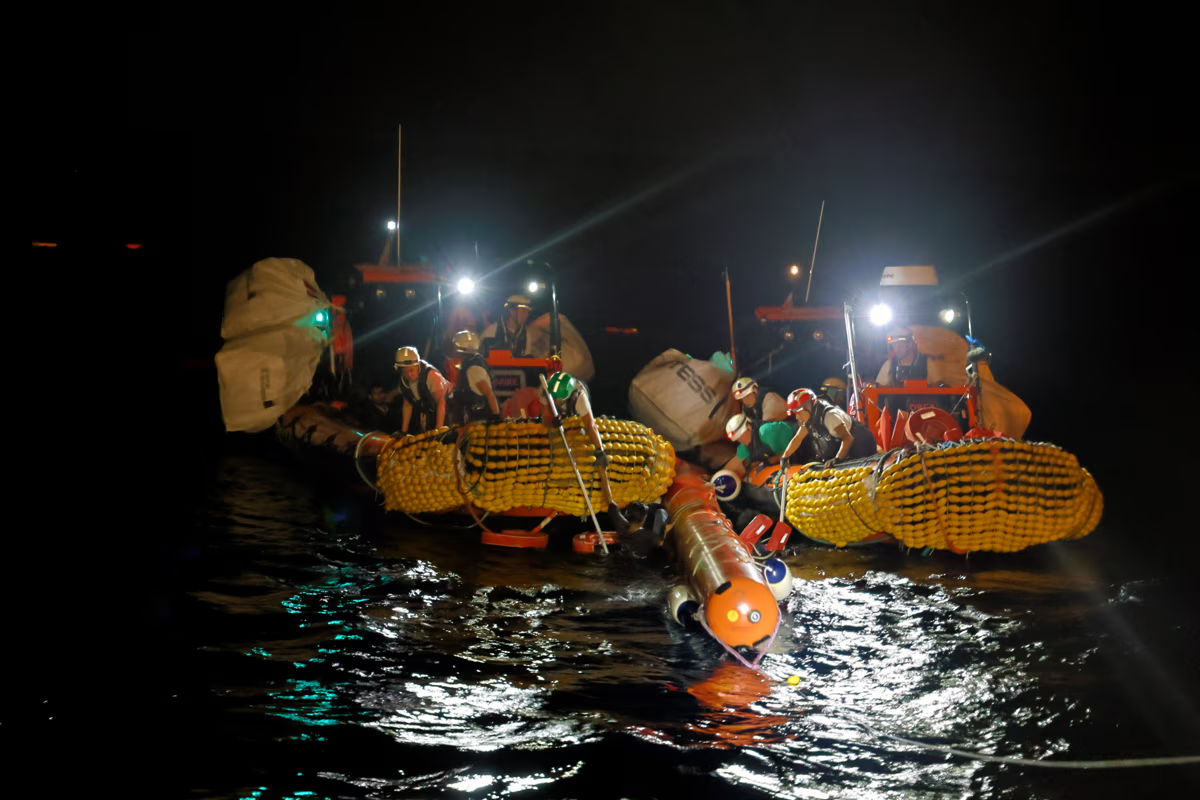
378;417;674;517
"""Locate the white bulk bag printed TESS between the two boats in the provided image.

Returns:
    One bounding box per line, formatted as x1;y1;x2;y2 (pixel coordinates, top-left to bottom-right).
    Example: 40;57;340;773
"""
629;349;737;451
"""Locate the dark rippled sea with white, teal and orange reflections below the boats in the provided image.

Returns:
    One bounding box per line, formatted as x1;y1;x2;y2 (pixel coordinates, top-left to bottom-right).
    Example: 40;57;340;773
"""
142;455;1200;800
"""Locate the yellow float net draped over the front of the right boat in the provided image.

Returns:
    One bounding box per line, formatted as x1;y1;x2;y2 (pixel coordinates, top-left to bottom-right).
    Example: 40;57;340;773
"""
787;439;1104;552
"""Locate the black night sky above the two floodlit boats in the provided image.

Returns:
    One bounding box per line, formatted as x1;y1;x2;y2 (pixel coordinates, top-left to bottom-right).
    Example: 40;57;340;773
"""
34;2;1196;470
